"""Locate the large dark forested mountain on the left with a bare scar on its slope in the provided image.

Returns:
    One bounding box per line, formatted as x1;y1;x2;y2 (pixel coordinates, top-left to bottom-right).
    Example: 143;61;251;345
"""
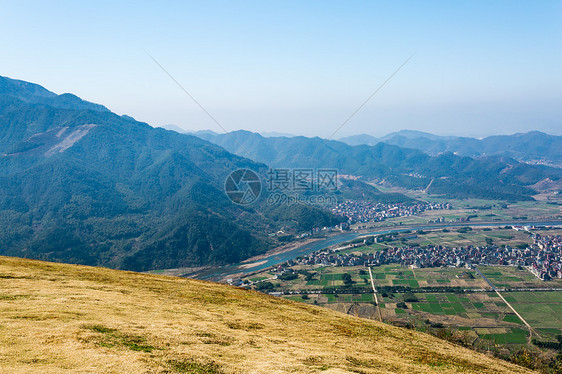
0;74;338;270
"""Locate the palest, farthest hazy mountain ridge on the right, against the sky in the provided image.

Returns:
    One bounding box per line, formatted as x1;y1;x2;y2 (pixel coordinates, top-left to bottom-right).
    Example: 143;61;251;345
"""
340;130;562;166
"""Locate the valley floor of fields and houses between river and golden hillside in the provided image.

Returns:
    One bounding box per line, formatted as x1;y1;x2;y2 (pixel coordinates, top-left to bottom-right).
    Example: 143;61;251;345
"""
237;225;562;372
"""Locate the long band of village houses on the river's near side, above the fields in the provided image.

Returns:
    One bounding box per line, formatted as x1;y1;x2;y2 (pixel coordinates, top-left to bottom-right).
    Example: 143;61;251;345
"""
286;234;562;280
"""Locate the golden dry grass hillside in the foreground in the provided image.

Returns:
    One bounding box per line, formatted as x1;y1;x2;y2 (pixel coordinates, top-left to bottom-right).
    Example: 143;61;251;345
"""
0;257;527;373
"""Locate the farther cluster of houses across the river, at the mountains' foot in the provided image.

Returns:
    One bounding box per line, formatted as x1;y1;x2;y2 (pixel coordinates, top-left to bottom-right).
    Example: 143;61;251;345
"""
332;200;452;223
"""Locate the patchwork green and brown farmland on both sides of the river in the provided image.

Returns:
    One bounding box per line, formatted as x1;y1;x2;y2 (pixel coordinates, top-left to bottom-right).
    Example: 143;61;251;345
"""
240;228;562;358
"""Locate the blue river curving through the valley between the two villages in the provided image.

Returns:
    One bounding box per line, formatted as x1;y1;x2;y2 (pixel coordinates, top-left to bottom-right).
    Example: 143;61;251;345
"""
196;221;562;281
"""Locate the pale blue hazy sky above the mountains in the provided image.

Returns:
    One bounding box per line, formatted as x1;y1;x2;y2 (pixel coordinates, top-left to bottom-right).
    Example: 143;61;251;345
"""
0;0;562;138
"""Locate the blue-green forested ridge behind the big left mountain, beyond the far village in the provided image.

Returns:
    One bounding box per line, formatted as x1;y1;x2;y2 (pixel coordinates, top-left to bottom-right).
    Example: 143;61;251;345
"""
195;131;562;200
